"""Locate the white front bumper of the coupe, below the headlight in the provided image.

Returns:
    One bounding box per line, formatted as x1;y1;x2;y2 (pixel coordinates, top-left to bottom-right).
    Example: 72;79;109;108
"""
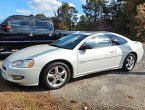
1;59;40;86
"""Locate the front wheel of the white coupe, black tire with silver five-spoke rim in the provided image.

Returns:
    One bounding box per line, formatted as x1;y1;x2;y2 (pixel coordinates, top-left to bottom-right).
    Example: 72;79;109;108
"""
41;62;70;89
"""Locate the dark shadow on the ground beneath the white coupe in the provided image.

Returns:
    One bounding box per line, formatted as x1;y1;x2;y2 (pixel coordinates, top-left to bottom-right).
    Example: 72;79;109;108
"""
0;70;145;92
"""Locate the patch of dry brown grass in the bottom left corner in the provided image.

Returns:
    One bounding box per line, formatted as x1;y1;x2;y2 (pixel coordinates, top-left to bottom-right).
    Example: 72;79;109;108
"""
0;92;66;110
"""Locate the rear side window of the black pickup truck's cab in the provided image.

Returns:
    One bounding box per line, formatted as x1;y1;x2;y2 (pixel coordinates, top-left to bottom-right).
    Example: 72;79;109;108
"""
35;20;50;29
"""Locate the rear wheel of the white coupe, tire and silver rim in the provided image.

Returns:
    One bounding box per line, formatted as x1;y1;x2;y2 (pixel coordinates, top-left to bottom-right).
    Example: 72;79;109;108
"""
122;53;137;72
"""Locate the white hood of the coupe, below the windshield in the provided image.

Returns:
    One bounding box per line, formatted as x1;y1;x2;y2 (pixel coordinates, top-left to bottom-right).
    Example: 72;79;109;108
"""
7;45;61;62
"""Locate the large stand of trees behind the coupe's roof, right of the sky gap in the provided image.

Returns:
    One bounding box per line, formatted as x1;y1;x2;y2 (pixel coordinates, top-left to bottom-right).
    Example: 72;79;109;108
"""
77;0;145;40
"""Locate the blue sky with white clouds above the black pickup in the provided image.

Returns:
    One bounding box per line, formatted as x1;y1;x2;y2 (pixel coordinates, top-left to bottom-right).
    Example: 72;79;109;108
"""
0;0;85;19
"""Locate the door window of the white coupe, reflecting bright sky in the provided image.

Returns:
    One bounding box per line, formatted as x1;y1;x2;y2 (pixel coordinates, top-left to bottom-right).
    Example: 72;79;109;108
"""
83;35;112;48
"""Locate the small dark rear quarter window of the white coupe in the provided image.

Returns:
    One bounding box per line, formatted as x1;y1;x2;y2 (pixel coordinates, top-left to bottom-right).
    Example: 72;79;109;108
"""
108;34;127;45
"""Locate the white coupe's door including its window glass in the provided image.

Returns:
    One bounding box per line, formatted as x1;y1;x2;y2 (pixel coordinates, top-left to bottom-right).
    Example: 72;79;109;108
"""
78;34;115;74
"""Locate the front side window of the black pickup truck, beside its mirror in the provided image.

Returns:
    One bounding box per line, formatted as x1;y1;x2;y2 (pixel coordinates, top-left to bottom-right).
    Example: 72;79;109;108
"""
10;18;30;30
